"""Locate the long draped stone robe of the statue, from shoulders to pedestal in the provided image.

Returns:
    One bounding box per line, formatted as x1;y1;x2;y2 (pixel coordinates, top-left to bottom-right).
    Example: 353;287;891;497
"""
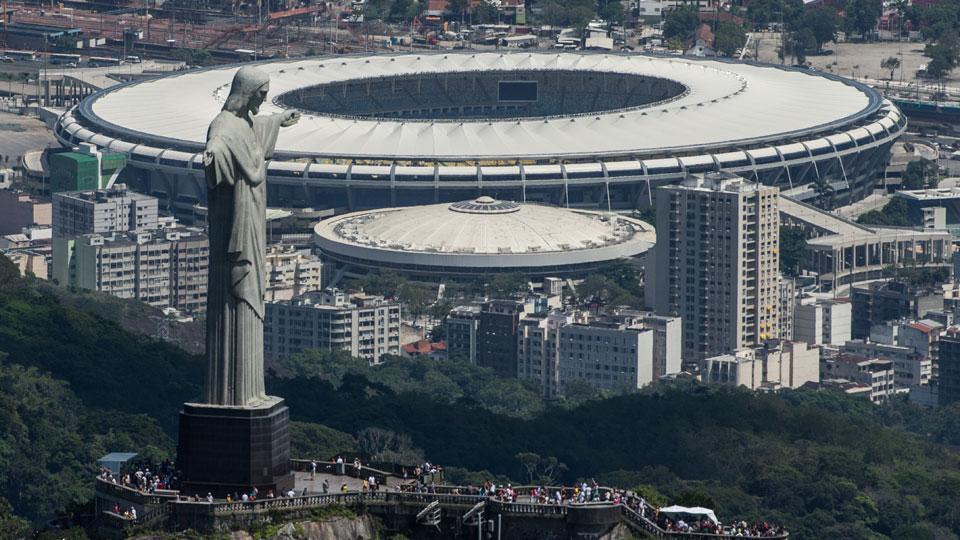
204;111;281;406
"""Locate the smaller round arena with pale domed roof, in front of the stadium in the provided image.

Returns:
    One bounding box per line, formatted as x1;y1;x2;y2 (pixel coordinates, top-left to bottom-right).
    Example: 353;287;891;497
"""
314;196;656;280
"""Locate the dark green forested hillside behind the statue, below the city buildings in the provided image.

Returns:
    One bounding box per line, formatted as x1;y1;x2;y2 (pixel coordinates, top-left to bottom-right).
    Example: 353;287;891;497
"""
0;258;960;539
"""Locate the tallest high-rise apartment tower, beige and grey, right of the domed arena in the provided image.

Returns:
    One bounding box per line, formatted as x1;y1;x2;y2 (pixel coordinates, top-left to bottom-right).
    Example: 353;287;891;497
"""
647;173;780;363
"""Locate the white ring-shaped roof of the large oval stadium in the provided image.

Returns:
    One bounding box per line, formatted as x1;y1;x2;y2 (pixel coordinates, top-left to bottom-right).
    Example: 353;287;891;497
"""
90;52;878;161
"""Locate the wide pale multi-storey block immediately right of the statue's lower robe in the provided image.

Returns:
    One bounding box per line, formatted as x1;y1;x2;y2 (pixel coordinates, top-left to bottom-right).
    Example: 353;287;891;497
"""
263;289;400;364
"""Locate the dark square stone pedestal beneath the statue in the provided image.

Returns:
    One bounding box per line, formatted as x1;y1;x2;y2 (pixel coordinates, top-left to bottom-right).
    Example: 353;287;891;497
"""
177;396;293;497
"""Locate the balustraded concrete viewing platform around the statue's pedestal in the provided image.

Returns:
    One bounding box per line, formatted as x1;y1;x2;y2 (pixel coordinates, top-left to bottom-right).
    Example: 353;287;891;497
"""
96;460;788;539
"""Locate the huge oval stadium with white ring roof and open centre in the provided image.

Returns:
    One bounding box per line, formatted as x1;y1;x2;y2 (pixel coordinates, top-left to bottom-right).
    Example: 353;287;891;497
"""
56;51;906;210
